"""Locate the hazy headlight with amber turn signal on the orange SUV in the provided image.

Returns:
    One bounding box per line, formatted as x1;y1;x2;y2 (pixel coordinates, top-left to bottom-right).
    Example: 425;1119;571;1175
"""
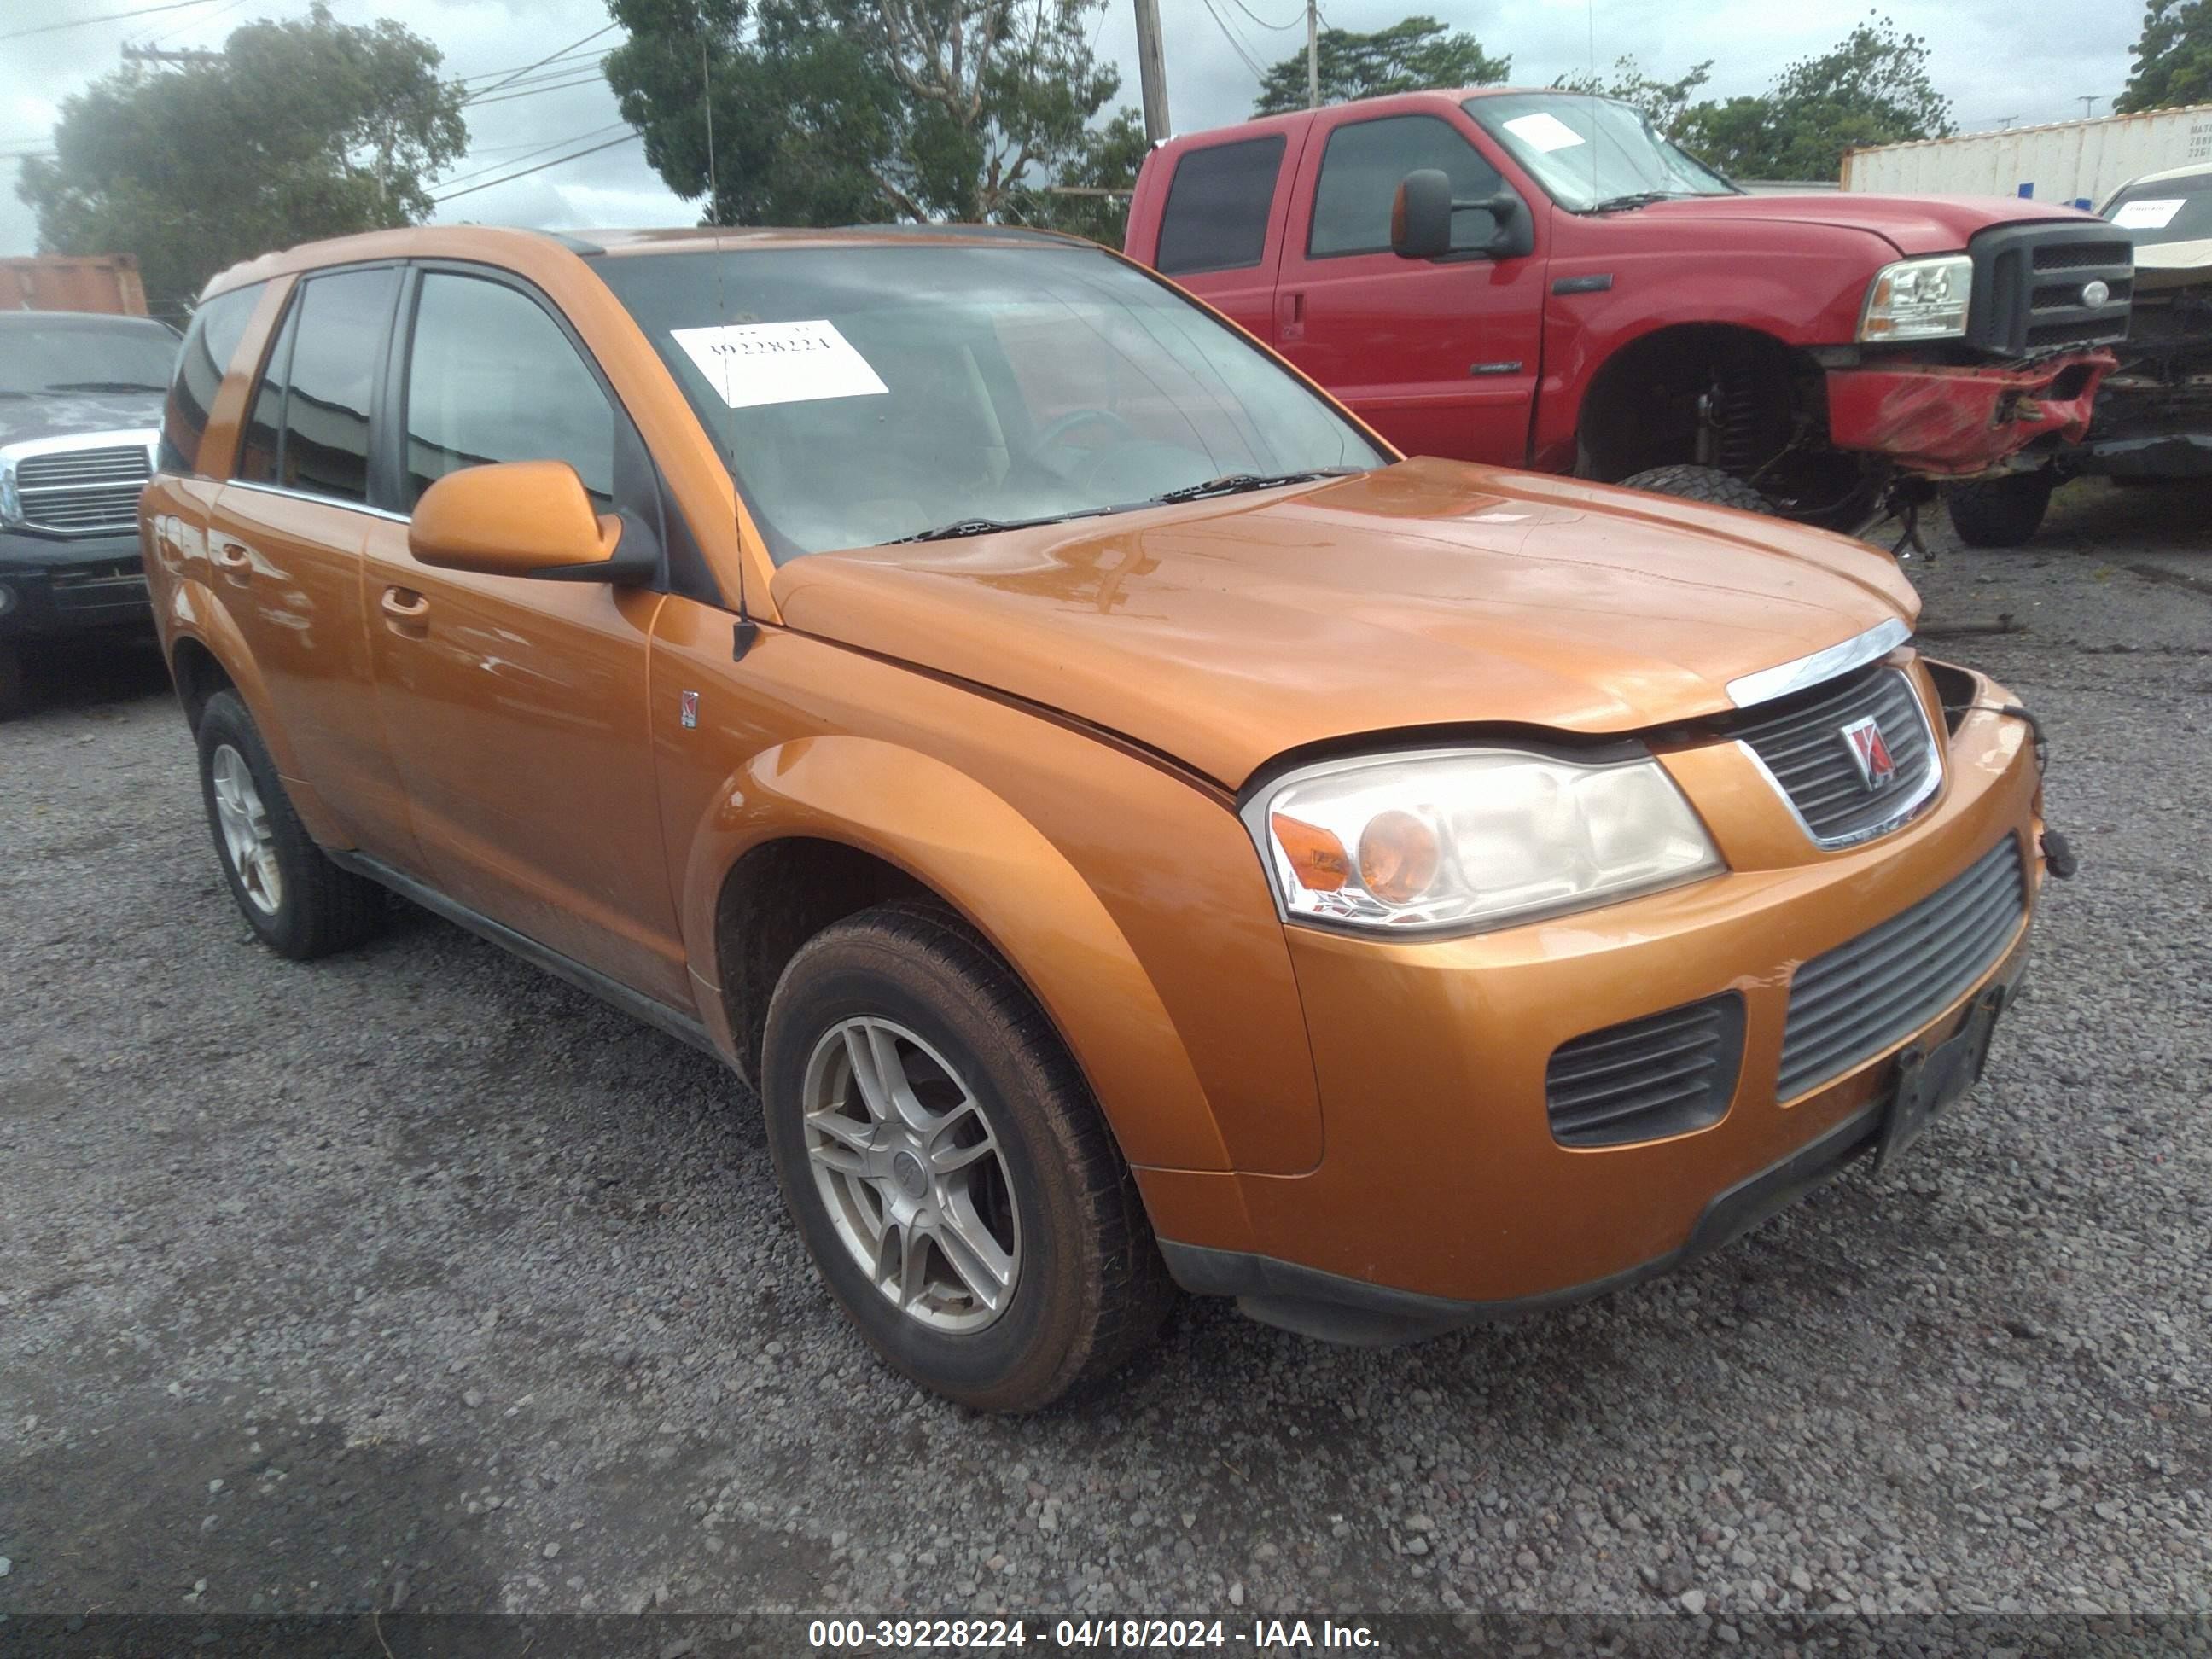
1243;750;1721;934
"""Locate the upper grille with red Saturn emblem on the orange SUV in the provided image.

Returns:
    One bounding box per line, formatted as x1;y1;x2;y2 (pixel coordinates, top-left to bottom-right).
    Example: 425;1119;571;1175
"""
1734;664;1942;847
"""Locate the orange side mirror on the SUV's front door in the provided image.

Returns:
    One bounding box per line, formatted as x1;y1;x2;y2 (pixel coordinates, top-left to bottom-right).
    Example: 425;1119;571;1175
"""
407;460;657;582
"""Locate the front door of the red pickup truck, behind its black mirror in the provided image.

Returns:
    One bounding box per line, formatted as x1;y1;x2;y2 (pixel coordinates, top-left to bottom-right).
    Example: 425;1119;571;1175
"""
1274;106;1551;467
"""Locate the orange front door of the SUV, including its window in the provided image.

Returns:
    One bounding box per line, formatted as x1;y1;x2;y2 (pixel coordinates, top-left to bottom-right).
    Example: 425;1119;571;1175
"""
363;270;692;1009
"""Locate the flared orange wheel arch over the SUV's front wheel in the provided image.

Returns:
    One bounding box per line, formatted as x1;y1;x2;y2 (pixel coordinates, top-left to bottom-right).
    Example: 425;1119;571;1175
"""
679;736;1230;1170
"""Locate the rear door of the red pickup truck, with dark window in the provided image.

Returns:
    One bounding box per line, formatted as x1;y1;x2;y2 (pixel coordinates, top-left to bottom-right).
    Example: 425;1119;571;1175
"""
1148;126;1305;345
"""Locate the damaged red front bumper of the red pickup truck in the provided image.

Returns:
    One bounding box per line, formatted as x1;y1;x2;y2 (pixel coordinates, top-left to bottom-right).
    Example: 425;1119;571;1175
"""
1827;352;2117;478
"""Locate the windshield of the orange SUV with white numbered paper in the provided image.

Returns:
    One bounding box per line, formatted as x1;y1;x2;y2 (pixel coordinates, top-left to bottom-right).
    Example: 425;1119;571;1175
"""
595;242;1382;562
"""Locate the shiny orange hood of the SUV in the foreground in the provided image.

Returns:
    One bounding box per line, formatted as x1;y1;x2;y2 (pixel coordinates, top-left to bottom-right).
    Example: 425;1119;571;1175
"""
774;460;1920;785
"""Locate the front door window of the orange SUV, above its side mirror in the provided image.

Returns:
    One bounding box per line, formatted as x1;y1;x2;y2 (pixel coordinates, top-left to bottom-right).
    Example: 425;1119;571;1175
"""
407;272;615;511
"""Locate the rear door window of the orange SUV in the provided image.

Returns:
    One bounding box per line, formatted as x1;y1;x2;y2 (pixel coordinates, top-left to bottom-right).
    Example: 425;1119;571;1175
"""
267;265;400;502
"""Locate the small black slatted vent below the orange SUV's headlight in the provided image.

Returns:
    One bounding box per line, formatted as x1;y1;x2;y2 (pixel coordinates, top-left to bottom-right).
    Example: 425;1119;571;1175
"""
1544;993;1743;1146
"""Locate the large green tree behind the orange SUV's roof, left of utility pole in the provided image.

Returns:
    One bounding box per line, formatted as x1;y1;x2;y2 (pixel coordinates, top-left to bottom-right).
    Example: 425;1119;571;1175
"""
606;0;1121;225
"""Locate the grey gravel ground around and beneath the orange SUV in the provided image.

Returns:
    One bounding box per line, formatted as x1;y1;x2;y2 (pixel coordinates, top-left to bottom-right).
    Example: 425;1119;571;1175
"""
0;486;2212;1634
